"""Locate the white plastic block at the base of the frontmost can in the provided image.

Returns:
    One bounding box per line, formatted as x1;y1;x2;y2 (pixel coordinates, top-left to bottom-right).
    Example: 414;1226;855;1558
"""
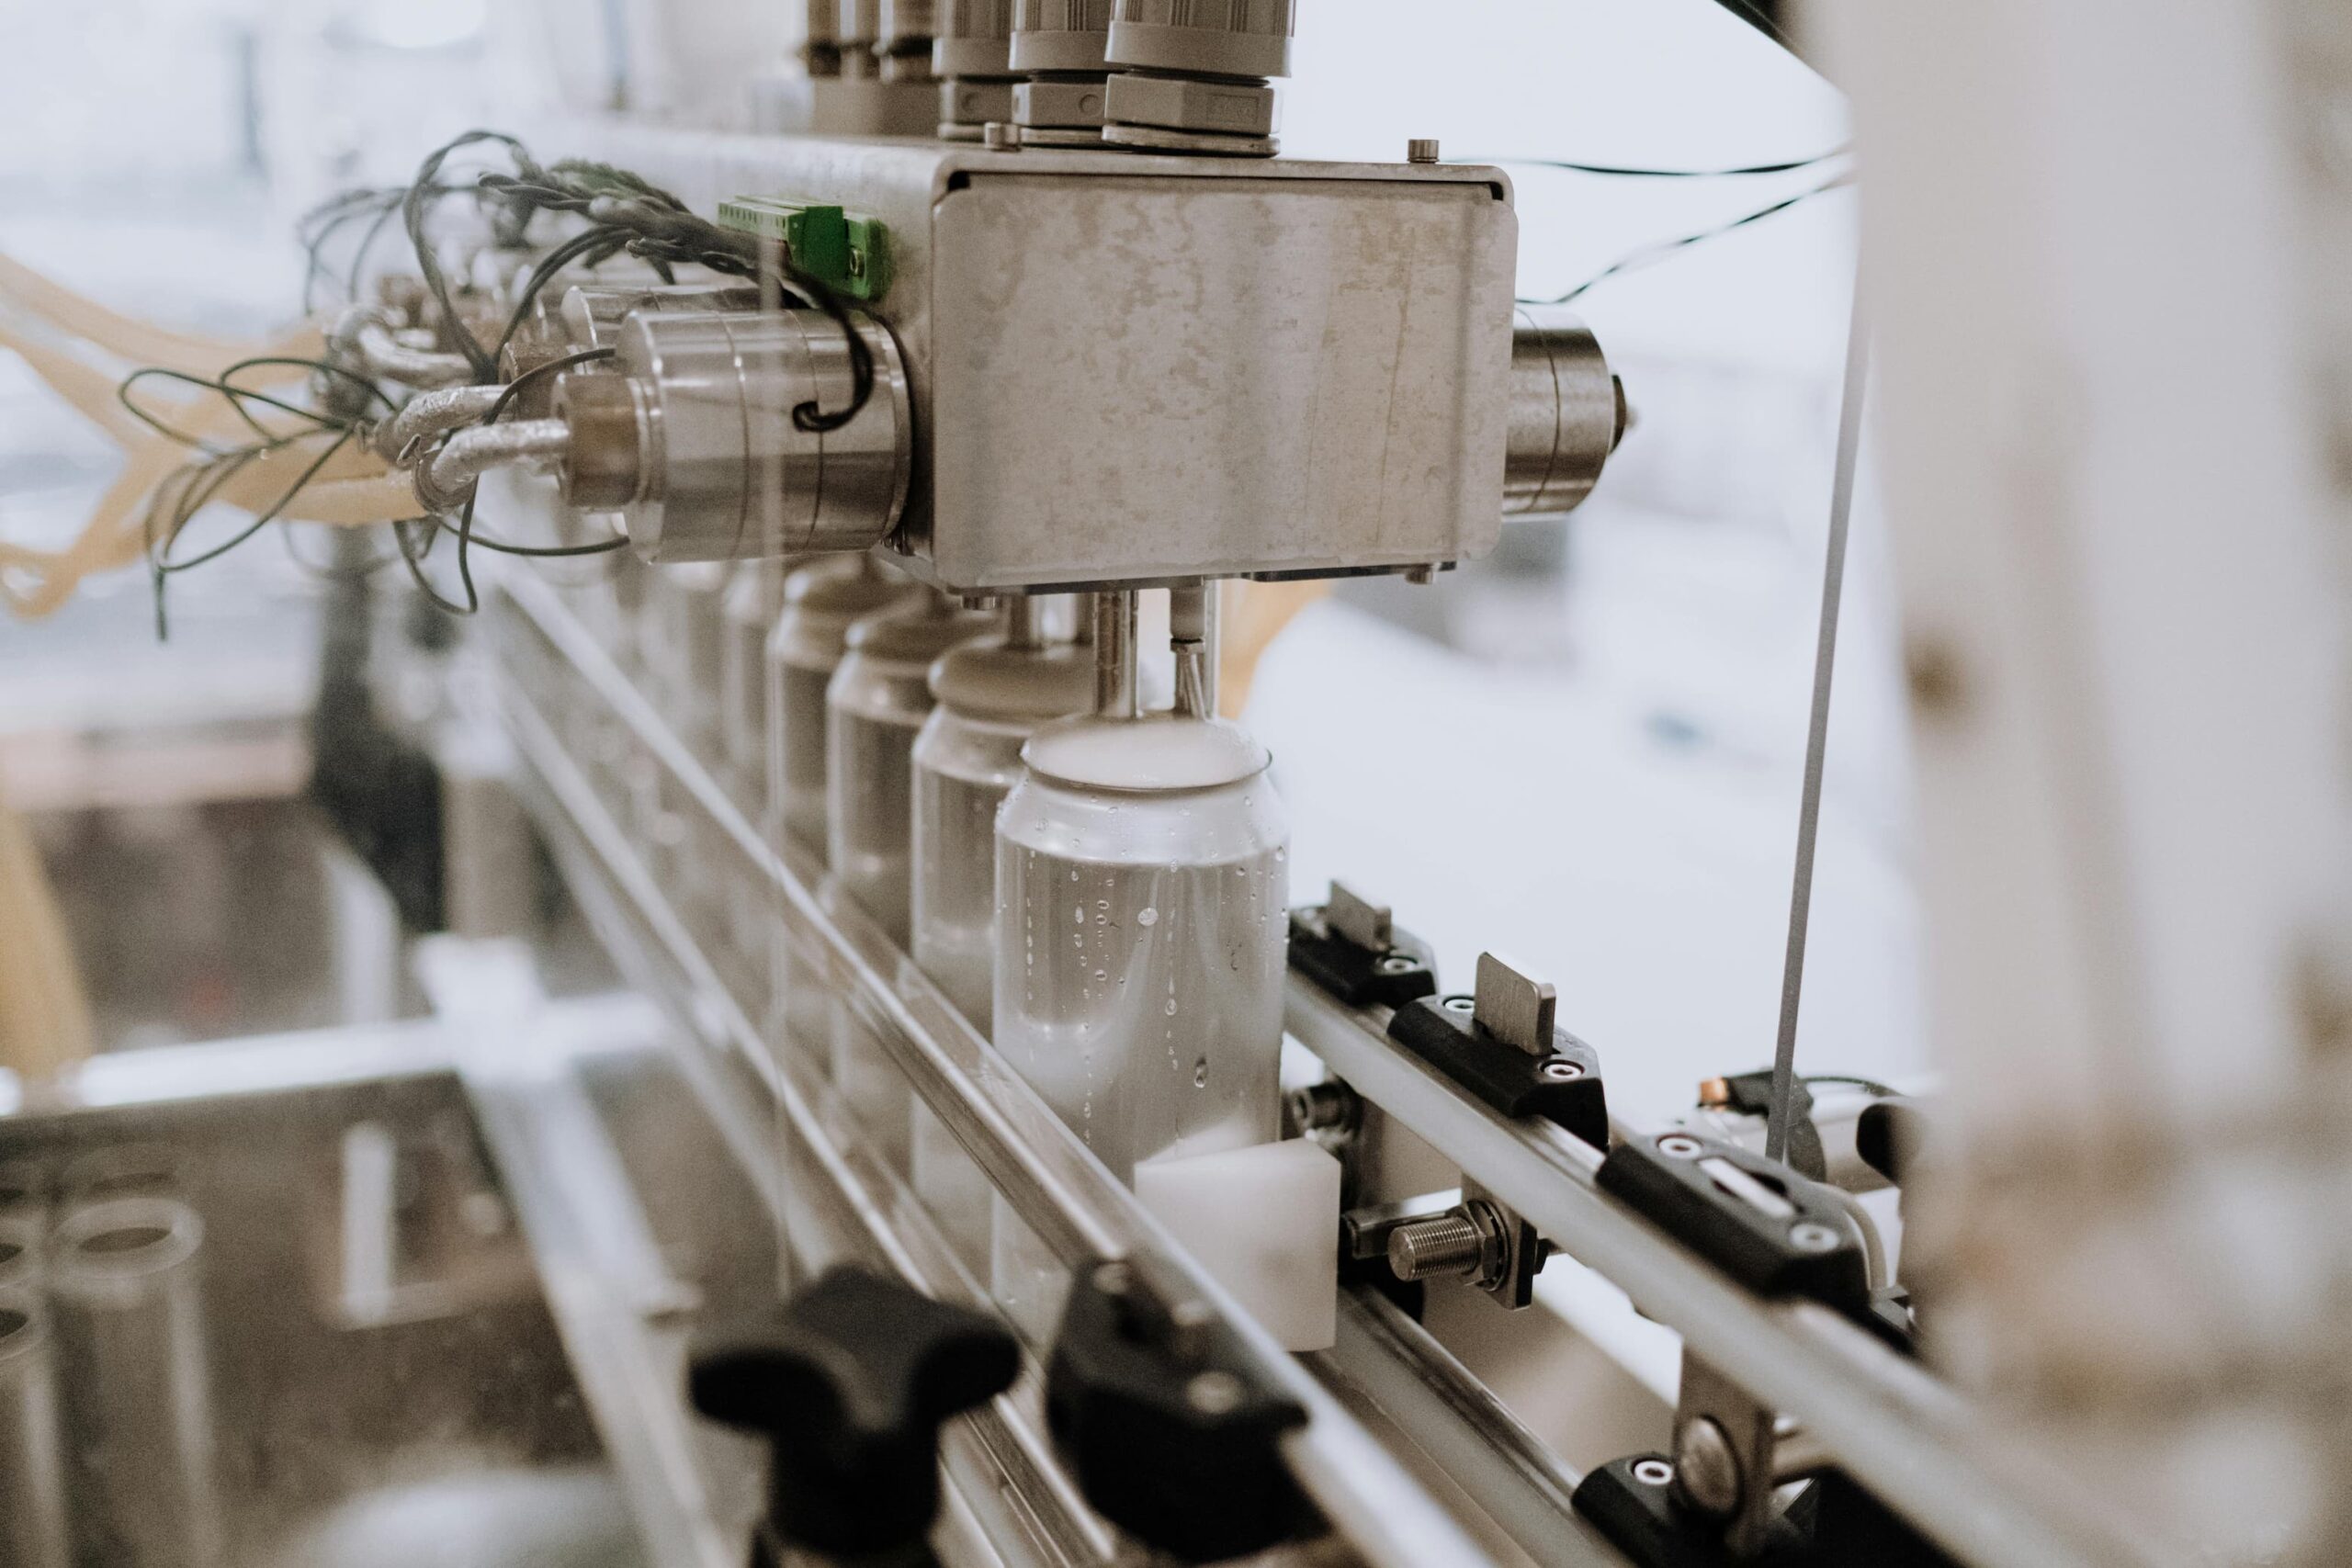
1136;1138;1339;1349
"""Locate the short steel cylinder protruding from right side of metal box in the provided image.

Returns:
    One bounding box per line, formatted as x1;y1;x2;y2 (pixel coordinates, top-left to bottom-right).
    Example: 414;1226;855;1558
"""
1503;306;1625;517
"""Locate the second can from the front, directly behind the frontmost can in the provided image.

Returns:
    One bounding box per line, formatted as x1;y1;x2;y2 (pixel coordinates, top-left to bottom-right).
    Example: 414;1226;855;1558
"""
908;600;1093;1272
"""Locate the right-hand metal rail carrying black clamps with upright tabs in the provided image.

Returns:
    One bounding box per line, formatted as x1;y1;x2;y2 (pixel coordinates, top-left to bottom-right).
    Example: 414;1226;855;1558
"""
1284;980;2133;1568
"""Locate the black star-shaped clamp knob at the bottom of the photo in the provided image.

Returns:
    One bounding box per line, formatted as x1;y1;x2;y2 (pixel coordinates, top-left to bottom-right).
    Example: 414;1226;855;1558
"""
687;1267;1021;1561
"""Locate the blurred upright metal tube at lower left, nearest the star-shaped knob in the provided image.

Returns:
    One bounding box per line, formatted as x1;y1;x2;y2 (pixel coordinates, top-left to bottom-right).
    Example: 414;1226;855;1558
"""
50;1197;223;1568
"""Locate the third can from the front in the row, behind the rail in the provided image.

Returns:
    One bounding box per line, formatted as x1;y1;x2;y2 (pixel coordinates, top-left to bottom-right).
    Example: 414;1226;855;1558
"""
826;597;1000;1168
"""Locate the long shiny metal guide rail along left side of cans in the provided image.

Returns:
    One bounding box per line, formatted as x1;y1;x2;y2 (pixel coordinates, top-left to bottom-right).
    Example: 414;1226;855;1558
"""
499;576;1482;1568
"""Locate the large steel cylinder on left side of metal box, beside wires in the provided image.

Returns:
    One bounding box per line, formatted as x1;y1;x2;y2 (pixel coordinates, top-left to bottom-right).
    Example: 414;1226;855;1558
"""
555;310;915;562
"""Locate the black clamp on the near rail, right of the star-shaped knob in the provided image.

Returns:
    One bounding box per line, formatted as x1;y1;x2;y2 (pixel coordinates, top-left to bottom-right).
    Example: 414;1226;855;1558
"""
1046;1260;1312;1563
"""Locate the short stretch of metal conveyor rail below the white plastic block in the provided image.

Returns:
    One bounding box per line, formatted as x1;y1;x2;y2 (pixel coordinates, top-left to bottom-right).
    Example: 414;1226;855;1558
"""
1307;1286;1621;1568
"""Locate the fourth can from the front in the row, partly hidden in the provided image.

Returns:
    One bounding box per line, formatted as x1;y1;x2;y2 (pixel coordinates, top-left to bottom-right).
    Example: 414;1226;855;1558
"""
762;555;924;1048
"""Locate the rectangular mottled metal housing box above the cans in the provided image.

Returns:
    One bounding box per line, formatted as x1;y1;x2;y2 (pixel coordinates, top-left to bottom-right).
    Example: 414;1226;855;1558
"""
548;127;1517;592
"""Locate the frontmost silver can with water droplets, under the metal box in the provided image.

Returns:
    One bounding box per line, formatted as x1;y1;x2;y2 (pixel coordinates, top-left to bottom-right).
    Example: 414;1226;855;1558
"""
995;715;1289;1180
